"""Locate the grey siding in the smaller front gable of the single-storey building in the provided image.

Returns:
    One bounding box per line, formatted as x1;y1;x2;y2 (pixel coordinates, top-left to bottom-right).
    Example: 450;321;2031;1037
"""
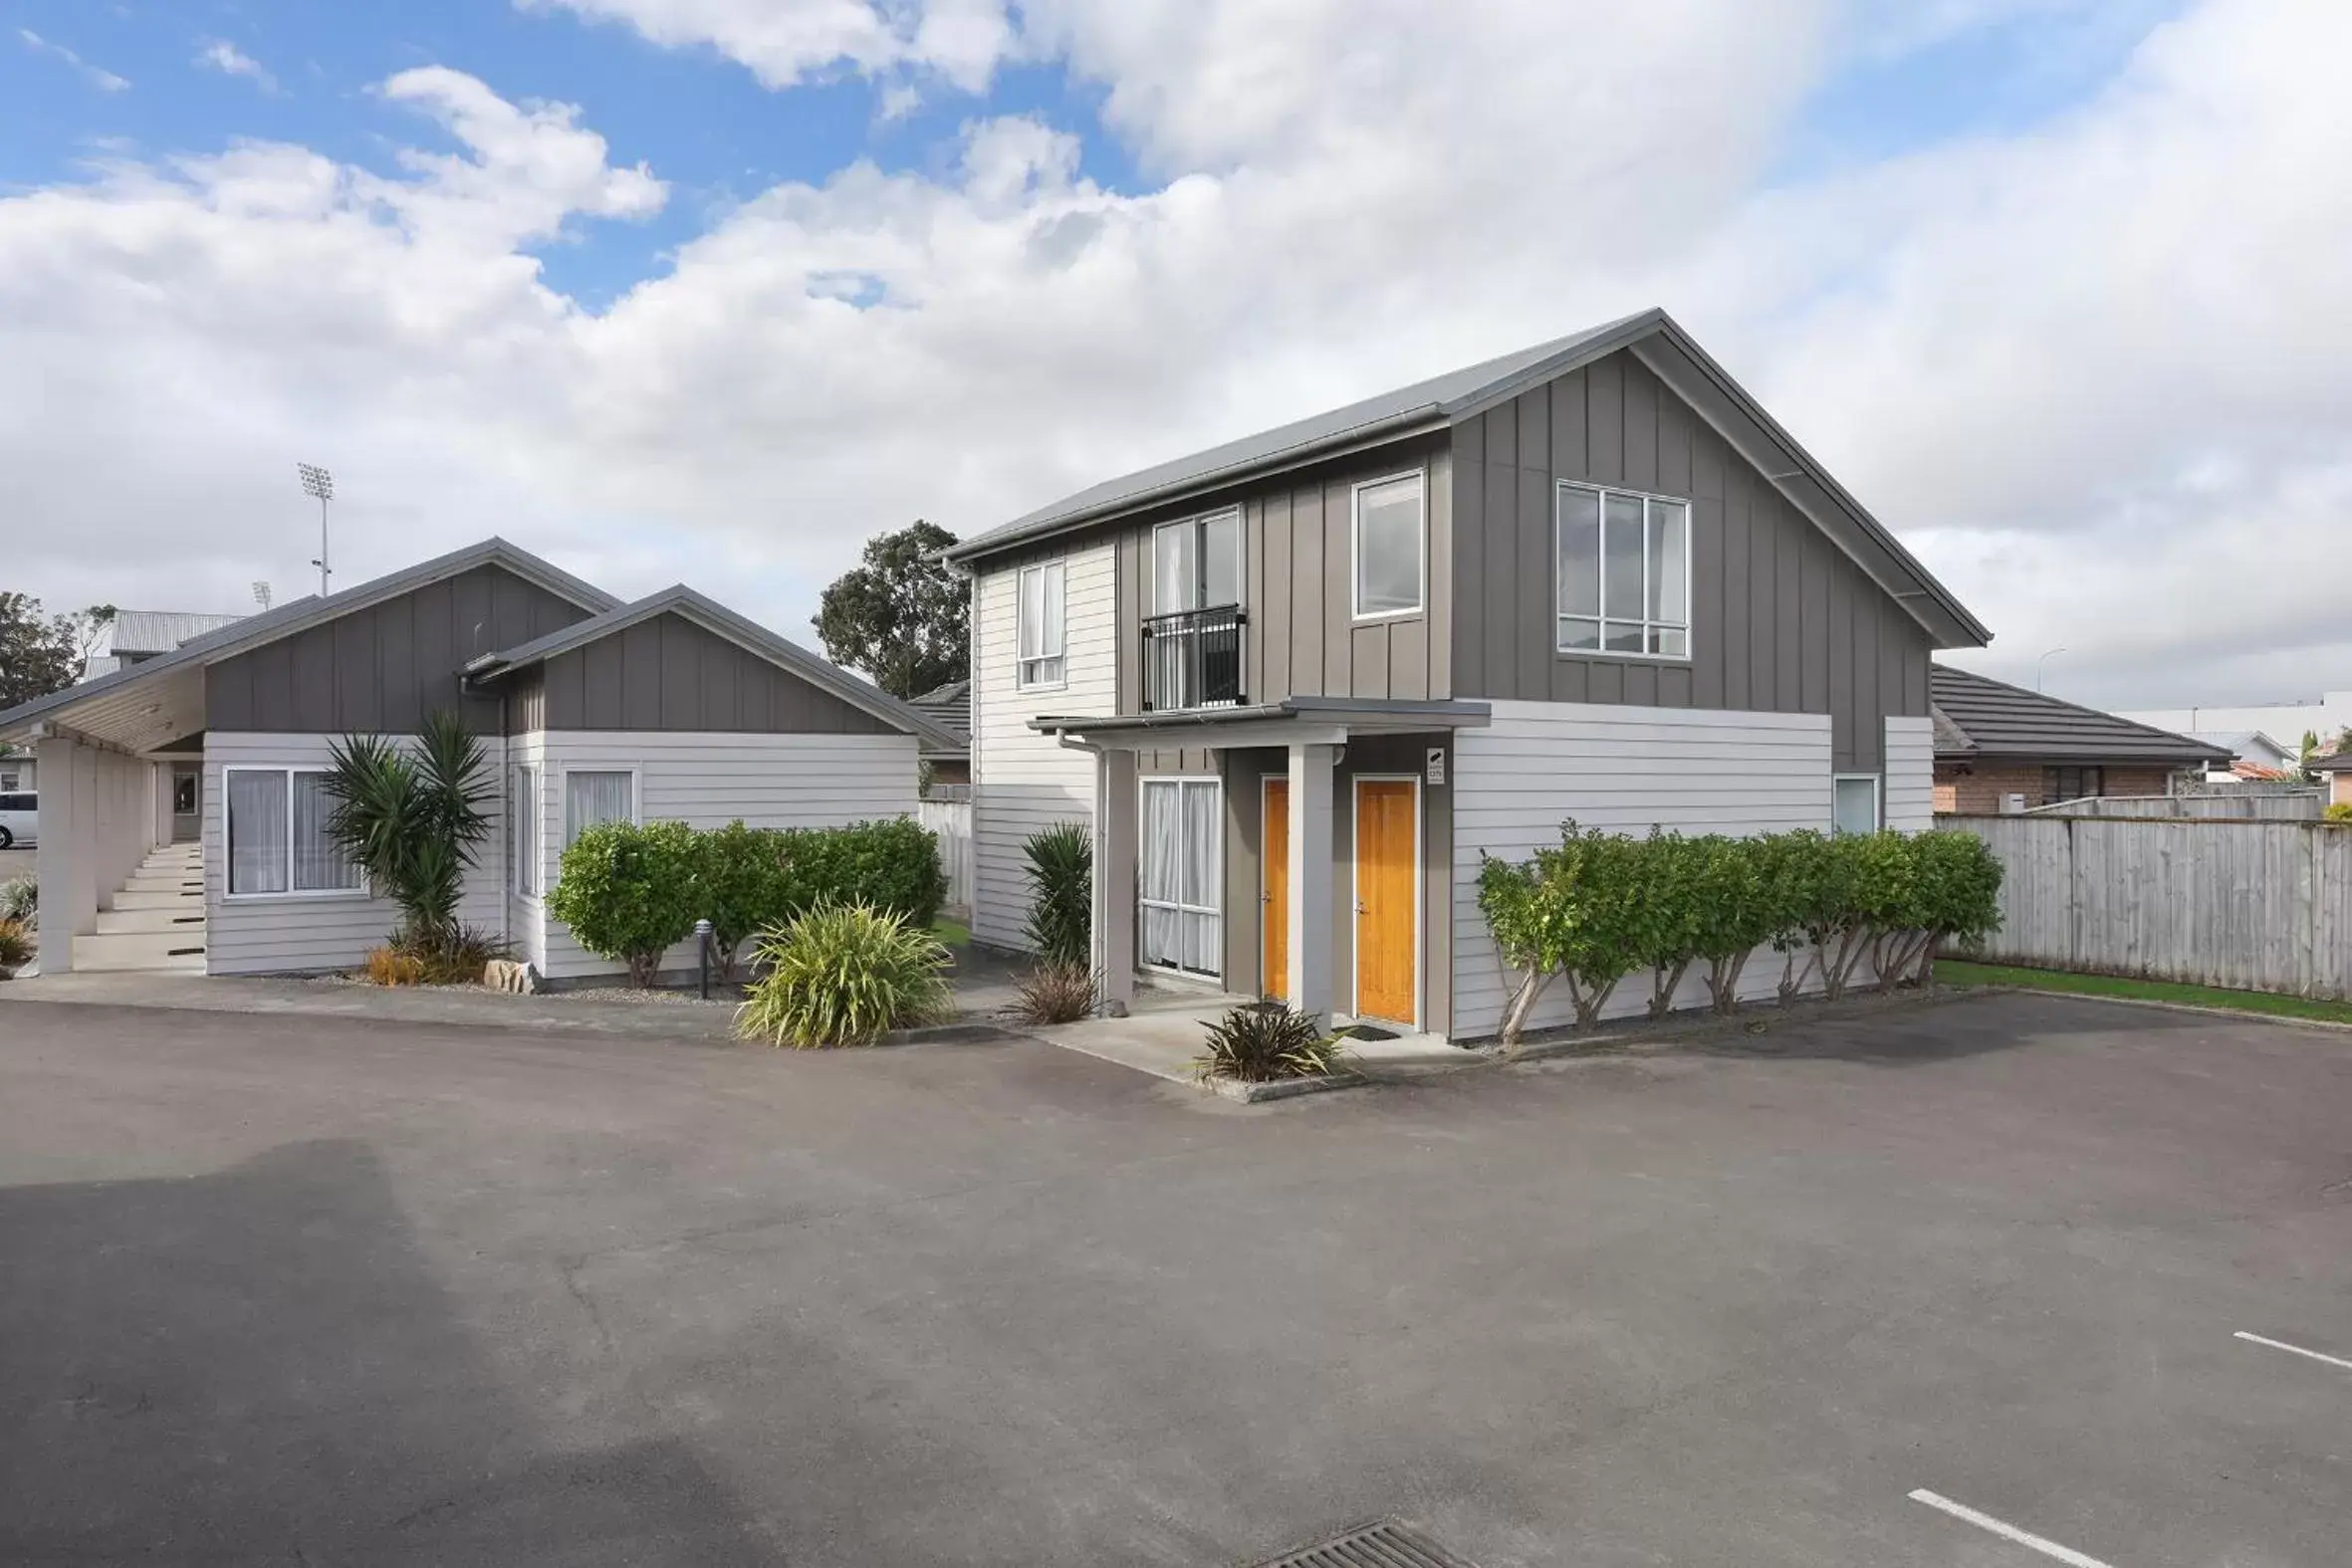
538;613;898;736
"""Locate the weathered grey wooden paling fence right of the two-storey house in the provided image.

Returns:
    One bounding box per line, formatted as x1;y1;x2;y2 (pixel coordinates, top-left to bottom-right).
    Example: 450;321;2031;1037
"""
1943;815;2352;1000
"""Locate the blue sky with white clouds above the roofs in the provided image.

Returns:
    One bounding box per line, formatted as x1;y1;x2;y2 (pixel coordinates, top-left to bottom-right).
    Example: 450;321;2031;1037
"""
0;0;2352;705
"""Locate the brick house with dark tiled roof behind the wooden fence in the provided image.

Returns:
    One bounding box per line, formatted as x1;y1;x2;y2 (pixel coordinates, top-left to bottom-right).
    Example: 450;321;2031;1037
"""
1929;665;2230;813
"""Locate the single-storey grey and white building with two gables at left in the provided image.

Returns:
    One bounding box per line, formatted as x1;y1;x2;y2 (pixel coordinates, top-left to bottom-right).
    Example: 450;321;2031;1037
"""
0;539;950;981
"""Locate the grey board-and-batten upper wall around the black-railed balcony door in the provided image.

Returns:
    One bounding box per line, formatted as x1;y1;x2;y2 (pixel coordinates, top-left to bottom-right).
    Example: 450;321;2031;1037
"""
1117;440;1454;712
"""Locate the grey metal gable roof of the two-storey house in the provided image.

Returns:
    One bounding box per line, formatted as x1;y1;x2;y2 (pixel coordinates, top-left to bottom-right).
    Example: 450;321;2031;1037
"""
946;308;1993;646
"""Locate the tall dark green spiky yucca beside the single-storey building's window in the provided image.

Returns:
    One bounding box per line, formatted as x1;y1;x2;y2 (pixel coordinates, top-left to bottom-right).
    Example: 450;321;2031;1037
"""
325;708;492;952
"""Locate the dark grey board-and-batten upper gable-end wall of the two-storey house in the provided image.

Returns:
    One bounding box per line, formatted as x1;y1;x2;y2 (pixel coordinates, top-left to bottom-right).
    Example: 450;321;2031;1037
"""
1454;352;1929;774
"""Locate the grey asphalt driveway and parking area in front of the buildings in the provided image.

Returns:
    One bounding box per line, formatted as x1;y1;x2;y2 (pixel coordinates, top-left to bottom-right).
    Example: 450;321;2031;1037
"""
0;997;2352;1568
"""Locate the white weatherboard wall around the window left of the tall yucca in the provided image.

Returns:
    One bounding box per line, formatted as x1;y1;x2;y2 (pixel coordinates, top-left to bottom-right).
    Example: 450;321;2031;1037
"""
204;731;506;976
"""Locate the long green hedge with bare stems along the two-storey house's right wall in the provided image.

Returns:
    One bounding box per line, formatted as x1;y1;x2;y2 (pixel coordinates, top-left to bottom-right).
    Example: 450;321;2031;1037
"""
1480;822;2001;1046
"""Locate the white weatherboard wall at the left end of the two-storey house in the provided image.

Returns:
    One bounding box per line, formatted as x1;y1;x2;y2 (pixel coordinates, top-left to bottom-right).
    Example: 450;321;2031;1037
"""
972;543;1117;948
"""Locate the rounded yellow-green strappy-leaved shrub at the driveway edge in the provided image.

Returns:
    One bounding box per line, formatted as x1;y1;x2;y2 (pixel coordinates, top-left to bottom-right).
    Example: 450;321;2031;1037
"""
736;905;953;1046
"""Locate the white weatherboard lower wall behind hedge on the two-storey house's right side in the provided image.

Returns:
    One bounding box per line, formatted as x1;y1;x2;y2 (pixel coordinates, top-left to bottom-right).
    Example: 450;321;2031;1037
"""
1451;701;1832;1039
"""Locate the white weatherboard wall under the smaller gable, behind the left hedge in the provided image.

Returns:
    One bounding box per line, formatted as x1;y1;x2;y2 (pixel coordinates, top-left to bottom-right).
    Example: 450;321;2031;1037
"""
531;729;920;981
